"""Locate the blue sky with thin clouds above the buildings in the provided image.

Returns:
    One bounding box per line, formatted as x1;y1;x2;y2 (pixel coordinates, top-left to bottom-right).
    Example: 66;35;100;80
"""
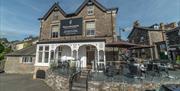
0;0;180;40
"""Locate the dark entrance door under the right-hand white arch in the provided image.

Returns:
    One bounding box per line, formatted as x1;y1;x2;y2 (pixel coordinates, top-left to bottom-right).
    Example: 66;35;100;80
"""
86;46;95;69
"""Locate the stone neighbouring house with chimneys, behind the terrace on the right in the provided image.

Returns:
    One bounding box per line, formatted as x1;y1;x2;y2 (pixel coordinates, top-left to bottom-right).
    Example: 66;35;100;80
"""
128;21;176;59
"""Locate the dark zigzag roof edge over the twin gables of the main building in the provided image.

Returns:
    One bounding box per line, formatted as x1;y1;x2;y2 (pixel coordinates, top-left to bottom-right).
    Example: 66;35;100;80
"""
39;0;118;20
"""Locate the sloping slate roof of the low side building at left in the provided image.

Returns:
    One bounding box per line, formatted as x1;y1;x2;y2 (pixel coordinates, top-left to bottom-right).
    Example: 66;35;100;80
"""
6;45;36;56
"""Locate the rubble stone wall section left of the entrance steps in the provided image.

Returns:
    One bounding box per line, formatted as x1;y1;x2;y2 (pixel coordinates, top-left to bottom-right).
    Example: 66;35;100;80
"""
45;70;69;91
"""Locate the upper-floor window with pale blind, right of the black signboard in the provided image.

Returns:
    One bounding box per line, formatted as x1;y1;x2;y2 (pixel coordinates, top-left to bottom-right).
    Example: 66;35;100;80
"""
86;21;95;36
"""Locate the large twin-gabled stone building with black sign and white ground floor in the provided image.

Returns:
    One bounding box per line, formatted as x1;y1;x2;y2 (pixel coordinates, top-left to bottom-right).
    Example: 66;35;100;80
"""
34;0;118;76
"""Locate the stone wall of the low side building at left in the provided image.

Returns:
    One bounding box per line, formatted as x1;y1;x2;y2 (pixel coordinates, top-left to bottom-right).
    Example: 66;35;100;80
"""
4;57;35;74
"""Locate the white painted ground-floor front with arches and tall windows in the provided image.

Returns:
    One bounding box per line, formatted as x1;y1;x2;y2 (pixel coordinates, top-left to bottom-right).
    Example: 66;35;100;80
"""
35;41;106;70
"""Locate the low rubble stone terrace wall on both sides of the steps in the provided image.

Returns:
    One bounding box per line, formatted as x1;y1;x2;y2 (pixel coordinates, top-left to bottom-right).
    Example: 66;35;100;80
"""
45;71;179;91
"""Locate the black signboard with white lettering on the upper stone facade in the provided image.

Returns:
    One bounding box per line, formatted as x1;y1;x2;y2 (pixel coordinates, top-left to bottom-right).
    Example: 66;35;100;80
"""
60;18;83;36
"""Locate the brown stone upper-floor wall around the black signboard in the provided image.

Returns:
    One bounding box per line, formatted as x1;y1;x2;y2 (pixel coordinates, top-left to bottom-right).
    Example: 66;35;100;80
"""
40;2;116;42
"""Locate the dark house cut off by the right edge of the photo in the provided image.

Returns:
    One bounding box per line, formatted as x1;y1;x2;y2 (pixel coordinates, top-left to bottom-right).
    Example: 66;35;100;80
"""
166;26;180;63
